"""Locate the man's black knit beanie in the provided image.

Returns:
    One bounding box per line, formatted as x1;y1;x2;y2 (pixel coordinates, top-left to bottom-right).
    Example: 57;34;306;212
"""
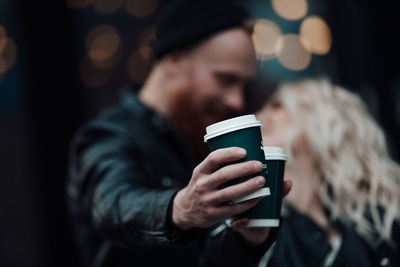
152;0;248;59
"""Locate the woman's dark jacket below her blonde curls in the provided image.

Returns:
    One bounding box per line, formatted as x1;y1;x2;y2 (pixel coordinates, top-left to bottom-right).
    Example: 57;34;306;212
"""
203;205;400;267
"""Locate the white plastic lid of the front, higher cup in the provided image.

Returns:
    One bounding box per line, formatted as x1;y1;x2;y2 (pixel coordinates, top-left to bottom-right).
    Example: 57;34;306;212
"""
204;114;262;142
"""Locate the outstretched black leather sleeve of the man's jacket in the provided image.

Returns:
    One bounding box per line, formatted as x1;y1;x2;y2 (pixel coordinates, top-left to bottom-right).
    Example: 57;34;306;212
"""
70;122;192;248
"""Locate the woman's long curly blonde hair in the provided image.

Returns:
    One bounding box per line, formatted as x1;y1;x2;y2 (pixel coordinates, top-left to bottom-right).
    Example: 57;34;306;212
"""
276;79;400;246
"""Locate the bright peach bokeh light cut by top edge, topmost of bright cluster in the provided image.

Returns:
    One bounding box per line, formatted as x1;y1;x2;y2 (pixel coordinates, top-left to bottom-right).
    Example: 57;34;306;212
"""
271;0;308;20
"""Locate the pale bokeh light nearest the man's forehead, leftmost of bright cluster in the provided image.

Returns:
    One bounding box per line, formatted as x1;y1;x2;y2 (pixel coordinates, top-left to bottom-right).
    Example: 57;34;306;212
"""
252;19;282;60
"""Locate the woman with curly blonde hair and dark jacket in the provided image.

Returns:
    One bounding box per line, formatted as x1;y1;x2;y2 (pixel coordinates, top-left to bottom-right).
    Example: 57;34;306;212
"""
256;80;400;266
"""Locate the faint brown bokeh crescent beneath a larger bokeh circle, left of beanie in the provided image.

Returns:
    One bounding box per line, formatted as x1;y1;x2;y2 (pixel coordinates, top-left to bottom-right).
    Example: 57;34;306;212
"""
80;57;111;87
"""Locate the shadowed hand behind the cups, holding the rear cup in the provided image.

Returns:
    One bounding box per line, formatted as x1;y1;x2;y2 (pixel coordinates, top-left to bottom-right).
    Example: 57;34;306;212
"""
232;180;292;246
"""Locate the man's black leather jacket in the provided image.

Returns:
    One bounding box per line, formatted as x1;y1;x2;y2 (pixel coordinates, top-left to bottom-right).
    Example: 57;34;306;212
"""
67;91;272;266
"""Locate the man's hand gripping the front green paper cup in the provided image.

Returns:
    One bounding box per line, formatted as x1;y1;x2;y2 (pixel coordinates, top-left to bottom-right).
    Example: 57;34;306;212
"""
172;147;265;230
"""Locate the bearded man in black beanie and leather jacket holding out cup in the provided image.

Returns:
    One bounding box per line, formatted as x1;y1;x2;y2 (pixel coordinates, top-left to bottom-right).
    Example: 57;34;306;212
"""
68;0;289;266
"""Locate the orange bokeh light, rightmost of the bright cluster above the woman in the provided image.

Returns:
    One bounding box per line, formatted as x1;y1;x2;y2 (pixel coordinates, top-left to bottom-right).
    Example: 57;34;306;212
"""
300;16;332;55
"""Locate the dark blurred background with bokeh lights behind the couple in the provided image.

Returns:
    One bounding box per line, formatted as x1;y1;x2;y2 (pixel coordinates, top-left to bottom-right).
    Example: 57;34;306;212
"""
0;0;400;266
